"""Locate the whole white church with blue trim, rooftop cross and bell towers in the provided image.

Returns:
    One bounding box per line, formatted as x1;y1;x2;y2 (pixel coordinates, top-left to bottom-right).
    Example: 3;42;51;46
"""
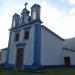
0;3;75;70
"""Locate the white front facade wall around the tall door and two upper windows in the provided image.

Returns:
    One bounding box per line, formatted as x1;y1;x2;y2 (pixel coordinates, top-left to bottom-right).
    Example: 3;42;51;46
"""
8;26;34;65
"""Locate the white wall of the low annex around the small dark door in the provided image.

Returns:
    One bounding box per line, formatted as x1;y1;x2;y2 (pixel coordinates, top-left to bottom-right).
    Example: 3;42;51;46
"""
64;50;75;65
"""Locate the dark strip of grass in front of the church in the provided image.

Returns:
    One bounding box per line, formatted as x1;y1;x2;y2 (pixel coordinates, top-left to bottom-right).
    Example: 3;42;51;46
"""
0;68;75;75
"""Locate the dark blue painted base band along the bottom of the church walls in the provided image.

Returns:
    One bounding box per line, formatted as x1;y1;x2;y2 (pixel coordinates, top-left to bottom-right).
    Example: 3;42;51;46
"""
5;64;75;71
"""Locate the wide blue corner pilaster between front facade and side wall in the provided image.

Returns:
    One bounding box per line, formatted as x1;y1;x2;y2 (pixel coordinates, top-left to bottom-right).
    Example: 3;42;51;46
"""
33;22;41;68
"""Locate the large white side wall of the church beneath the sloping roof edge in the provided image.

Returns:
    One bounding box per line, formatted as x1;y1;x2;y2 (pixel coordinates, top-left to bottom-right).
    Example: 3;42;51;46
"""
41;27;64;65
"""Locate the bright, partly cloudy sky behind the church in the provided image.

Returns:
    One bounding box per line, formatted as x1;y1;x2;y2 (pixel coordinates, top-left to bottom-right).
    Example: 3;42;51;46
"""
0;0;75;49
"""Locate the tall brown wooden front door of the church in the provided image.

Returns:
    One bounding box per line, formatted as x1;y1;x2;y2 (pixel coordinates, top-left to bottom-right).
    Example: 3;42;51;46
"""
16;48;24;69
